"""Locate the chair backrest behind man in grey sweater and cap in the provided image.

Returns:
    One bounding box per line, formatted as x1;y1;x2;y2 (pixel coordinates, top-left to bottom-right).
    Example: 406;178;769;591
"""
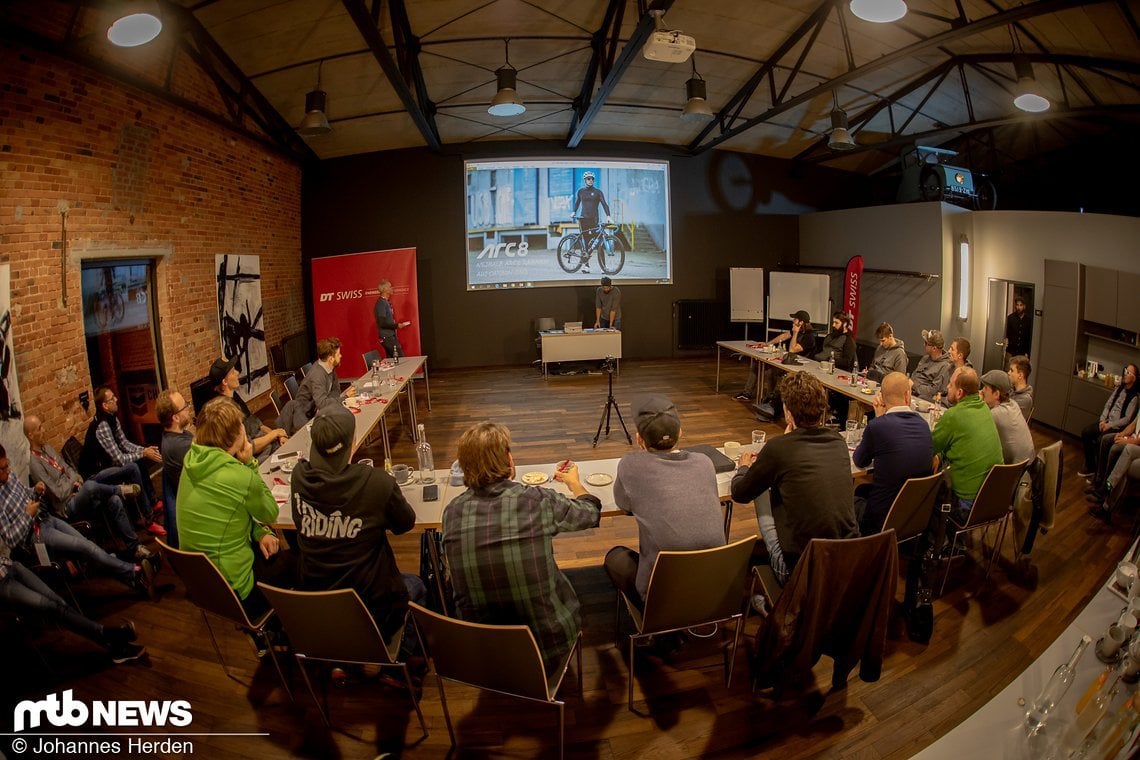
642;536;757;631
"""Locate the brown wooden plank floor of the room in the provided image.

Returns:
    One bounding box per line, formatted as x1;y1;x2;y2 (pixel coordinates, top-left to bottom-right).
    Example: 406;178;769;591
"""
0;357;1131;760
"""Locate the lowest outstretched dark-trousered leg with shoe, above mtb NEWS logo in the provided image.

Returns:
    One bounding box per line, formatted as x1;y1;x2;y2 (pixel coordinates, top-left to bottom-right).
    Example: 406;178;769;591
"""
0;558;146;664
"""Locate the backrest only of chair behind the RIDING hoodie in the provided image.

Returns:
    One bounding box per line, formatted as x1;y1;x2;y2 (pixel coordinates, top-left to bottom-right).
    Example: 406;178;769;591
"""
258;582;392;664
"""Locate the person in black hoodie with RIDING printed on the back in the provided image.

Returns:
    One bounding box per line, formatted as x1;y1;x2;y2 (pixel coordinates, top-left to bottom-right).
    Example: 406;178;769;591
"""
291;404;428;655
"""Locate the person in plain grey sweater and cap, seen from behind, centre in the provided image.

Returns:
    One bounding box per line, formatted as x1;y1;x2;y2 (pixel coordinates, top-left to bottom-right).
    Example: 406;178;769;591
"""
605;395;724;607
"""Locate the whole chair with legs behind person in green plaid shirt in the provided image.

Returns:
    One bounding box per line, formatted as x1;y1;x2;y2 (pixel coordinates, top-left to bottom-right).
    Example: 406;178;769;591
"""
408;602;581;758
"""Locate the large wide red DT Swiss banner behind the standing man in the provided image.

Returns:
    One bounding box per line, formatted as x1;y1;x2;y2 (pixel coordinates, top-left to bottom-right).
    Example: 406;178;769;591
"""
311;248;423;377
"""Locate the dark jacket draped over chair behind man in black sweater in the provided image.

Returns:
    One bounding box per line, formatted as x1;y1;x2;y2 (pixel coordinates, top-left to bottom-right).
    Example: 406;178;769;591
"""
751;530;898;697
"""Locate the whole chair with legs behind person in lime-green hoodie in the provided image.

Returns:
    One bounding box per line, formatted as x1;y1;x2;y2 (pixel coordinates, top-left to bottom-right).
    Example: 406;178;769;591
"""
158;540;293;701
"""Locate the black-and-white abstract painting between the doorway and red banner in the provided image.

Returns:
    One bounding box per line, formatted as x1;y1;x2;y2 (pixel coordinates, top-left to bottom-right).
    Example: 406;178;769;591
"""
214;253;269;399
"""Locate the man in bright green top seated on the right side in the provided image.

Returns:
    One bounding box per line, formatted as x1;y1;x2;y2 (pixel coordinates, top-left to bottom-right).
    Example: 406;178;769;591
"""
931;367;1002;521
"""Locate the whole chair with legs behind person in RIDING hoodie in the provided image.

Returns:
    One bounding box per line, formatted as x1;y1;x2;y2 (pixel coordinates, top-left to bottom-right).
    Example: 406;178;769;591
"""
258;582;428;737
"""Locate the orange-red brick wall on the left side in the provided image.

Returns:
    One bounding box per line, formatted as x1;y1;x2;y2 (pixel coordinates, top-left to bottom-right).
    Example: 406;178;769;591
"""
0;44;304;443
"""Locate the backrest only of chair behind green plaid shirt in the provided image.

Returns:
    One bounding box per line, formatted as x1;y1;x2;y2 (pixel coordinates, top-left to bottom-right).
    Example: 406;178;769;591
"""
408;602;551;702
